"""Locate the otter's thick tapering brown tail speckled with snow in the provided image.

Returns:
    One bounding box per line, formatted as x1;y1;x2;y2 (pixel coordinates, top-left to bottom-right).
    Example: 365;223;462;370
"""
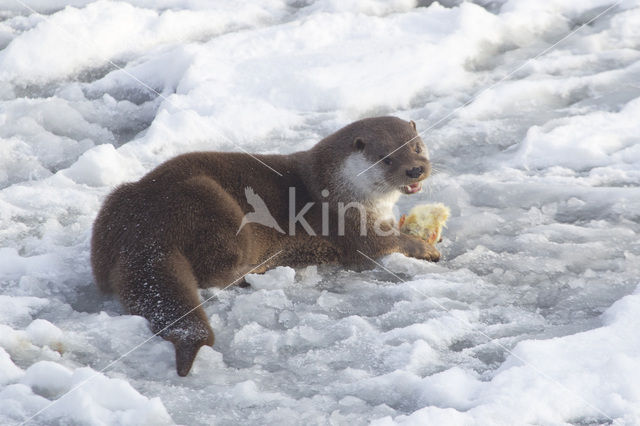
116;252;214;376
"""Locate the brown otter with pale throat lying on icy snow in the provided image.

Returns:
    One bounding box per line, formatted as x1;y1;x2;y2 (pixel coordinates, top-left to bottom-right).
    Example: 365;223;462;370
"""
91;117;440;376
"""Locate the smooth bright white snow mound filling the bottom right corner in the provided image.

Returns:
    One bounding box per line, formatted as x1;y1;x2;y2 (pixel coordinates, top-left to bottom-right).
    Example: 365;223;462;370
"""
373;289;640;425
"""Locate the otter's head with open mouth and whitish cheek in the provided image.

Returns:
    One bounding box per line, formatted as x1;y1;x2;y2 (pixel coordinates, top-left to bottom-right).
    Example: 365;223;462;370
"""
343;117;431;198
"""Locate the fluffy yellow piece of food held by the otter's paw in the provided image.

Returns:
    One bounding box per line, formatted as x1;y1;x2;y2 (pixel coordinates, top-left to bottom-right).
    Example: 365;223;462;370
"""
398;203;451;244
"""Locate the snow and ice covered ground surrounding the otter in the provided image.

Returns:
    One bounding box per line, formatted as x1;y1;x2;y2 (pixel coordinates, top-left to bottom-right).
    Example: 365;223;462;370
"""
0;0;640;425
